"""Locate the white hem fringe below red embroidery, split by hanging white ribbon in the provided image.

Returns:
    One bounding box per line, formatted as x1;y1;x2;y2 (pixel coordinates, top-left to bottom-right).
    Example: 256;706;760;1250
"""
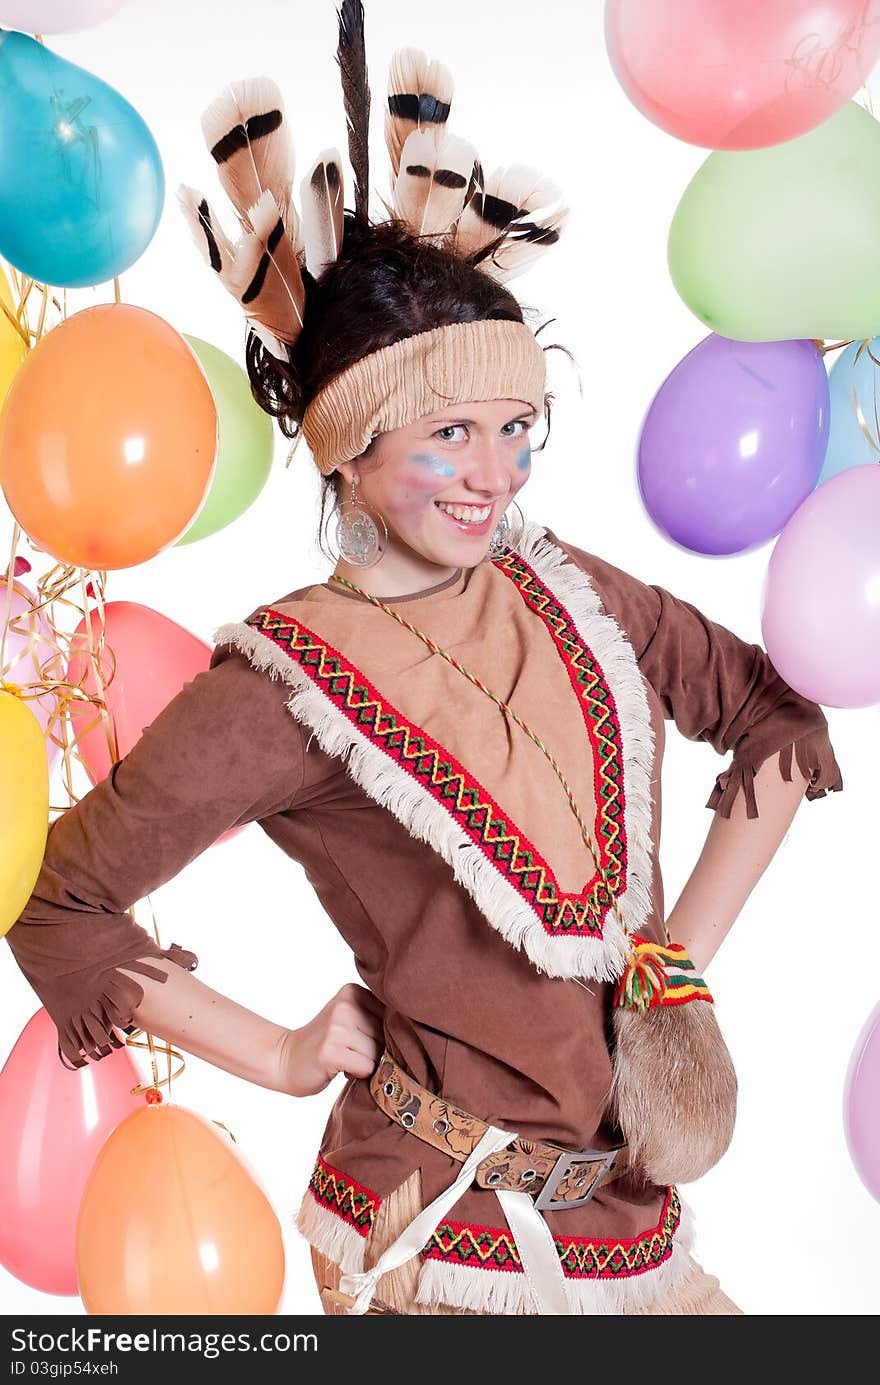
416;1204;694;1316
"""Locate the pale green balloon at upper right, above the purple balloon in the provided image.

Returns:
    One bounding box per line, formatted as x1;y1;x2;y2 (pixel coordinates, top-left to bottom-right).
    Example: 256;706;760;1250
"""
668;102;880;341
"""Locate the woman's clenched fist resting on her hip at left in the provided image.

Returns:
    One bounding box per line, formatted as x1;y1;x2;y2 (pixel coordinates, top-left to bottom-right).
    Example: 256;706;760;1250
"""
281;982;385;1097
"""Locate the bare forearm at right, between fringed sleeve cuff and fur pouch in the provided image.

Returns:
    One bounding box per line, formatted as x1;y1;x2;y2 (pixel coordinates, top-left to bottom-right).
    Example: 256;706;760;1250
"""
667;755;807;971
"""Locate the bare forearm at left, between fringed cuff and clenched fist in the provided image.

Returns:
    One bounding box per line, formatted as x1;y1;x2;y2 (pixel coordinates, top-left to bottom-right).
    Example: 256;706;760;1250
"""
119;957;291;1091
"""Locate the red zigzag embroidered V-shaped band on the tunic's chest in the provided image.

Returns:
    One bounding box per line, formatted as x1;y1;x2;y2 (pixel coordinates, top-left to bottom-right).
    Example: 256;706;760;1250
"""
247;550;628;939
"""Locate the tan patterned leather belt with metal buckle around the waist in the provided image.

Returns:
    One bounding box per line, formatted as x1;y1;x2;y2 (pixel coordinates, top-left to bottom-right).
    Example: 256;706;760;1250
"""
370;1051;629;1212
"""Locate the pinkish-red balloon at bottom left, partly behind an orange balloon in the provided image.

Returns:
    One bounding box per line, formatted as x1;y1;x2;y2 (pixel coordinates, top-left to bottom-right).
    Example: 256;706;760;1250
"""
0;1007;143;1294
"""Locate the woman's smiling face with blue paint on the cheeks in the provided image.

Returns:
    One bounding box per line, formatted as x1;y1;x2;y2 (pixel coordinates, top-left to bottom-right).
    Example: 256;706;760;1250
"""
340;399;538;571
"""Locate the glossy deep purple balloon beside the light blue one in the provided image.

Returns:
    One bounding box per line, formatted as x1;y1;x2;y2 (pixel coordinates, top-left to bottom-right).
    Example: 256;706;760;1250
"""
637;335;829;554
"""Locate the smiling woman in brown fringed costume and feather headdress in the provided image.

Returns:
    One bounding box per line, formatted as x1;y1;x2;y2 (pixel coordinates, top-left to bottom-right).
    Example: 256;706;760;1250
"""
7;3;841;1314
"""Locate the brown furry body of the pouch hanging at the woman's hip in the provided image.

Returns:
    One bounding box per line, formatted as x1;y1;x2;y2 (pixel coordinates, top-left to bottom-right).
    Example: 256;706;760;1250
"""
611;1001;736;1184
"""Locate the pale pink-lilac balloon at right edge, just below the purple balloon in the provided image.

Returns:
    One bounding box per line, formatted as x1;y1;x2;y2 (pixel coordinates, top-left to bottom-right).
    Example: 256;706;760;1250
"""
762;467;880;706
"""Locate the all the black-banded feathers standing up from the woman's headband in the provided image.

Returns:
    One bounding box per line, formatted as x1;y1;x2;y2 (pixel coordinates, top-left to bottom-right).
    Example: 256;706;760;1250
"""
177;0;568;360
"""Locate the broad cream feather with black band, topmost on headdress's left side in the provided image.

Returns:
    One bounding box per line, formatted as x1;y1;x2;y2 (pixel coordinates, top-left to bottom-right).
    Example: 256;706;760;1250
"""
202;78;299;248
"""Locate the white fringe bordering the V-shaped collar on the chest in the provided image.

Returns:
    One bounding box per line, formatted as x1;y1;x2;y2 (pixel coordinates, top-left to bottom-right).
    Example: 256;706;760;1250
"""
213;521;654;981
